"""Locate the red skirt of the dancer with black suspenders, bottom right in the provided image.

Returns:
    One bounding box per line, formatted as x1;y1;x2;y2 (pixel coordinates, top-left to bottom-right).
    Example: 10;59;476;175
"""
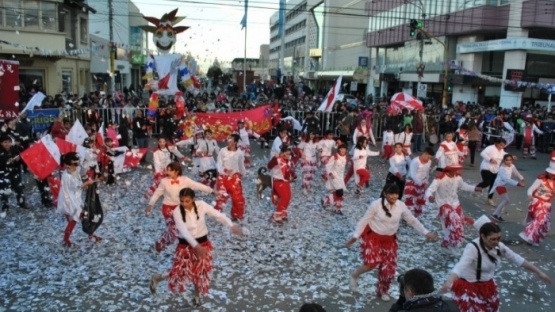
451;278;499;312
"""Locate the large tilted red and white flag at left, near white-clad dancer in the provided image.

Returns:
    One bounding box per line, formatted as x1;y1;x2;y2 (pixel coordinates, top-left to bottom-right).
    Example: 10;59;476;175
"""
20;135;61;180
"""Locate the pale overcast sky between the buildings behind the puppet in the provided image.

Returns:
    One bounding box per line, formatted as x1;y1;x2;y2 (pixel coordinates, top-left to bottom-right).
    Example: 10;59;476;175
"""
133;0;279;70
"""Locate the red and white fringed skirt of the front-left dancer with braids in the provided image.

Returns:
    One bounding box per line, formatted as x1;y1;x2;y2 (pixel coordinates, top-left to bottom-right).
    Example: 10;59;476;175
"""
168;241;213;294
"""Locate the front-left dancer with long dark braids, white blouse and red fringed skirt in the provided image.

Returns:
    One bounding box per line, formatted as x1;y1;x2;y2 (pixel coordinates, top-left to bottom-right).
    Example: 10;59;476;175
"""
150;188;243;307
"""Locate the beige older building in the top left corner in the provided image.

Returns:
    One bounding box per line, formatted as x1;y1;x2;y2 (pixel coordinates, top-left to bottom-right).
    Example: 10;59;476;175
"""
0;0;96;95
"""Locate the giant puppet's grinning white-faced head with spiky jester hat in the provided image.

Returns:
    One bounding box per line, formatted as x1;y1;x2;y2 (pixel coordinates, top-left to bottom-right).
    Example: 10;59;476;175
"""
141;9;189;54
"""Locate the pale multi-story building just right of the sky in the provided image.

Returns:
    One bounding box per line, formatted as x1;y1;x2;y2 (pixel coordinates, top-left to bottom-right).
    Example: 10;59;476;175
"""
270;0;370;95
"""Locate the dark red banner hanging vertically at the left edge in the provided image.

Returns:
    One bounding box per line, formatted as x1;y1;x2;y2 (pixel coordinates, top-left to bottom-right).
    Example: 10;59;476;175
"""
0;60;19;119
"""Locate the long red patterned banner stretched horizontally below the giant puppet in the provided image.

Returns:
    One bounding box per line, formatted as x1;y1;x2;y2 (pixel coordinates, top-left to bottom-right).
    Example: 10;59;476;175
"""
181;104;278;141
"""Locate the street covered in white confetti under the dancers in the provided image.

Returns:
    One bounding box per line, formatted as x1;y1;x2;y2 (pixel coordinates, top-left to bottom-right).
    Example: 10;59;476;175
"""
0;144;555;312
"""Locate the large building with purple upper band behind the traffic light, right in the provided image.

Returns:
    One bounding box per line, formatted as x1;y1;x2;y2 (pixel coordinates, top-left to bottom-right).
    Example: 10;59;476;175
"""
366;0;555;107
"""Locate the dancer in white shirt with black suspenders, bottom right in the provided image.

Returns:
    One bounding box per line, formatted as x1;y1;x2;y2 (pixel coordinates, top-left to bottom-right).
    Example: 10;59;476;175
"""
440;222;551;312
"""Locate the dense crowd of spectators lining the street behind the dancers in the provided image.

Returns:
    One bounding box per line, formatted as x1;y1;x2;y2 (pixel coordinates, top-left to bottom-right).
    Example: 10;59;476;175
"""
11;81;555;152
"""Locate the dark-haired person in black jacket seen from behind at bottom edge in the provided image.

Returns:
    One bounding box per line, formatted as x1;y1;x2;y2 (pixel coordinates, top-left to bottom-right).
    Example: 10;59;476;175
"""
389;269;459;312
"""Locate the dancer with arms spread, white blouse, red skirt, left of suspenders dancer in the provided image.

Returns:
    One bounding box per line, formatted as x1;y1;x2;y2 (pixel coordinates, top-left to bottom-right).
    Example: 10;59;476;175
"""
345;184;437;301
